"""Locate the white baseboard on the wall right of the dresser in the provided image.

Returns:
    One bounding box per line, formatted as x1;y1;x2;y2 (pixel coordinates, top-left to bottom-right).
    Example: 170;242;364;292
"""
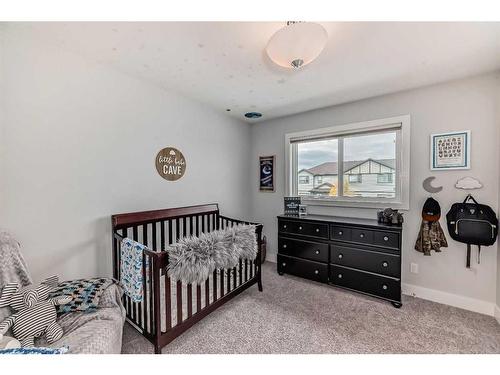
401;283;499;319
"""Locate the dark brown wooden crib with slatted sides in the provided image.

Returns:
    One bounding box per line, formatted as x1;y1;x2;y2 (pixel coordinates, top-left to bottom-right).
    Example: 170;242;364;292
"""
111;204;262;353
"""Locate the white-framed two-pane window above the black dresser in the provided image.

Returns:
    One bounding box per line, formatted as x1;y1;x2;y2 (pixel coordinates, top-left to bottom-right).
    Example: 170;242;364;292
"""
285;116;410;209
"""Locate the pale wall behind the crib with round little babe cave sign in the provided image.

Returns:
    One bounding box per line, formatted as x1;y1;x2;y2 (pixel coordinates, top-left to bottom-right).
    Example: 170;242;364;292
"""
0;30;250;280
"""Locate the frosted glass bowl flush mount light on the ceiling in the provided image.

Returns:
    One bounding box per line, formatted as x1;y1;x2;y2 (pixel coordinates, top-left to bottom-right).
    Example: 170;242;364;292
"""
266;21;328;69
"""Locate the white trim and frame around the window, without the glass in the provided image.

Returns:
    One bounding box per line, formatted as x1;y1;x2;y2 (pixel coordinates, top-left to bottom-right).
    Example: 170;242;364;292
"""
285;115;410;210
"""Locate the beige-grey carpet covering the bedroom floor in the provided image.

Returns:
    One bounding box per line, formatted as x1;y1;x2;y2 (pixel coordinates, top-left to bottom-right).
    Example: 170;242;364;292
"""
122;262;500;354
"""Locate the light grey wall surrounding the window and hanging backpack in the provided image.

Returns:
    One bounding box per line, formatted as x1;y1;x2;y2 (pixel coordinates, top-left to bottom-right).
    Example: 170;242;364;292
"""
251;73;500;314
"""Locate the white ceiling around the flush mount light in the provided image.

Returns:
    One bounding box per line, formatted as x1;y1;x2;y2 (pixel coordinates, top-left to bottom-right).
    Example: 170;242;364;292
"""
3;22;500;122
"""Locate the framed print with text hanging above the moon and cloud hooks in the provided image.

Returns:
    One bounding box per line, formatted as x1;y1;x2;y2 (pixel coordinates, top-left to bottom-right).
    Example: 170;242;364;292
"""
430;130;471;171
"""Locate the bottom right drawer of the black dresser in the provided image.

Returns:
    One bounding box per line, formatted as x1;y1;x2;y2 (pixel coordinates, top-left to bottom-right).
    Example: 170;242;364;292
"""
330;265;401;302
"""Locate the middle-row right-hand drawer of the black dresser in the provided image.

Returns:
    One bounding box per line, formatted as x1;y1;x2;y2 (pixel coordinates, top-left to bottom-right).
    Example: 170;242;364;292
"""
330;245;401;277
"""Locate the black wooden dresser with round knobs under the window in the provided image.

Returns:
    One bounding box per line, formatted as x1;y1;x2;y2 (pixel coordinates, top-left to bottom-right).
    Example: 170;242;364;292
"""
278;215;402;307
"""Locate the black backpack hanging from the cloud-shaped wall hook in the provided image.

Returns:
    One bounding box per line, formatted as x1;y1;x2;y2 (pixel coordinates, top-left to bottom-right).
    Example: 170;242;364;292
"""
446;194;498;268
